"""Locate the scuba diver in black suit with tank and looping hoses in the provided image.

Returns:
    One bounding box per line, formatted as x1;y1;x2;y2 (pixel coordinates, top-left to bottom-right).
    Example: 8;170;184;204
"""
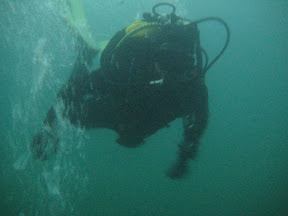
31;3;230;179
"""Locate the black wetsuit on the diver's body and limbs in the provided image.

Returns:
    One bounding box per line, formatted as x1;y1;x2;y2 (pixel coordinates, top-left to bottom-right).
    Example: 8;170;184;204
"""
32;23;208;177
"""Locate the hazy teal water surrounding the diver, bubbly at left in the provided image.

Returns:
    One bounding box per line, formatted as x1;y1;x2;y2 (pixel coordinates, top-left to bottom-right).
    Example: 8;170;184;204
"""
0;0;288;216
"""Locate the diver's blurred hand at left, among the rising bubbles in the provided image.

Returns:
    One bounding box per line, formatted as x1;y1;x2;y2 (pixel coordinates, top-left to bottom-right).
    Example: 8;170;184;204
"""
30;127;59;160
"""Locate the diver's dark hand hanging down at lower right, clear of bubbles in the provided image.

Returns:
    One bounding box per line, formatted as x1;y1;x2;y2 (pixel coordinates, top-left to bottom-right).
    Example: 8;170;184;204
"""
166;142;195;179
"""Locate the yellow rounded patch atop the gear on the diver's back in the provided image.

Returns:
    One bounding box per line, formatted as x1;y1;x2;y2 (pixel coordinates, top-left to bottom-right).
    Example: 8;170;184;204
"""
125;21;156;37
